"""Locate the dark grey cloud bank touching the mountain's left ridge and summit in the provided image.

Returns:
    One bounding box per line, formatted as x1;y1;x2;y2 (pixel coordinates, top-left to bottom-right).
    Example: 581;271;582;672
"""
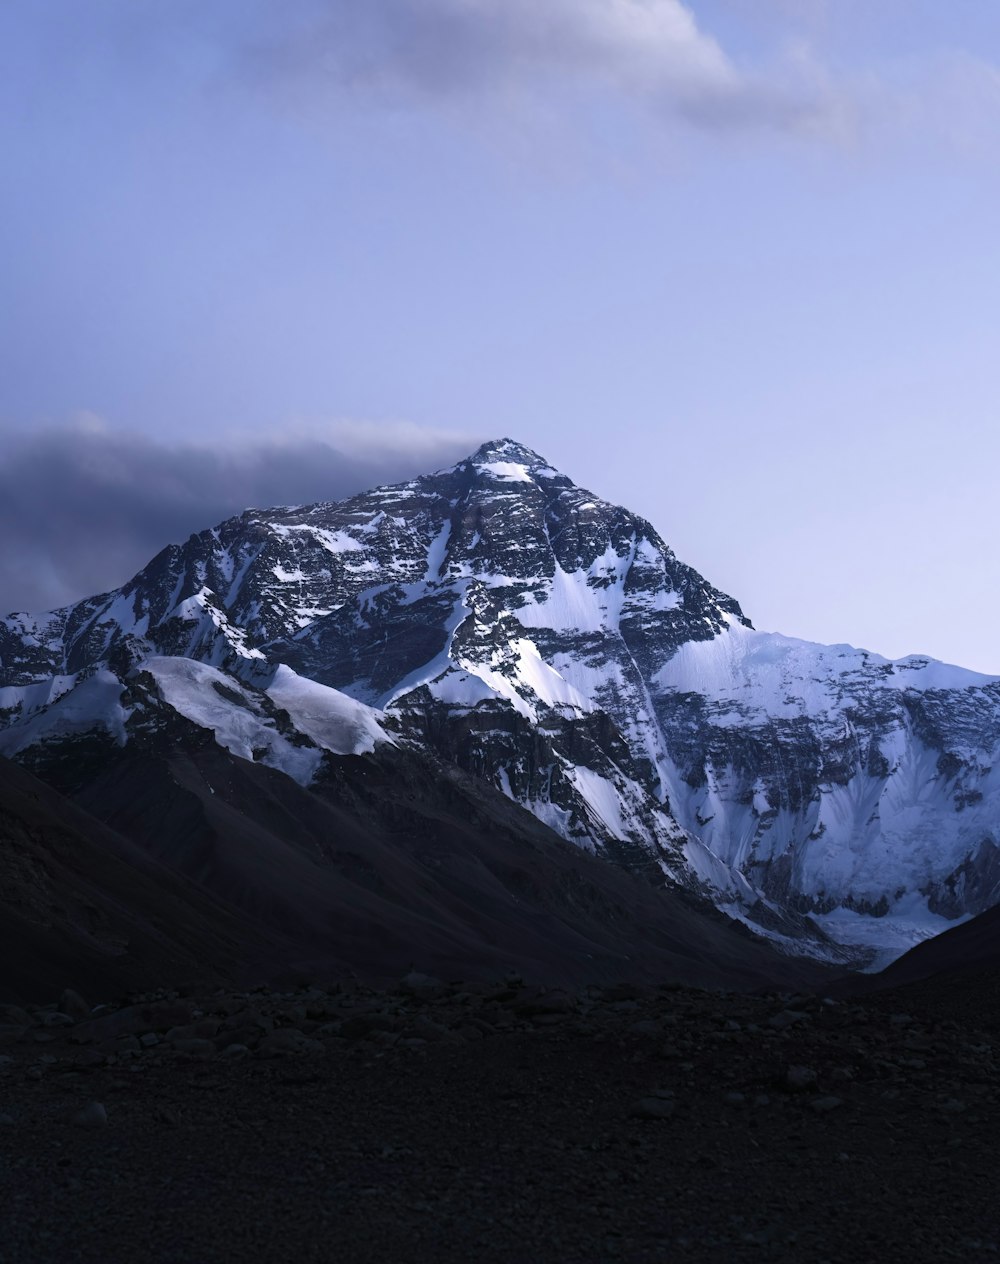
0;416;483;613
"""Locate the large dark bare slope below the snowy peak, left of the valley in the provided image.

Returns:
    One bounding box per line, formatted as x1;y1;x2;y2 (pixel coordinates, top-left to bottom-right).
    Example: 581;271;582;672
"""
0;729;827;999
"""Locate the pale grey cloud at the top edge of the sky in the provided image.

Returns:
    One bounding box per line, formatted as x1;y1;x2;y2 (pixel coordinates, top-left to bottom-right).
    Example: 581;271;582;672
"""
240;0;845;130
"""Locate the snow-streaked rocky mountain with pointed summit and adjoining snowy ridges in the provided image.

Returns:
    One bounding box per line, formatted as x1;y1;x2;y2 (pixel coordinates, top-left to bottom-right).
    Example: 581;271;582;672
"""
0;440;1000;959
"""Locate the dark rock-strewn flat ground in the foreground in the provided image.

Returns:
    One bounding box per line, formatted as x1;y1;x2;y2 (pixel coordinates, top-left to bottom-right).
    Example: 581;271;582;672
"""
0;975;1000;1264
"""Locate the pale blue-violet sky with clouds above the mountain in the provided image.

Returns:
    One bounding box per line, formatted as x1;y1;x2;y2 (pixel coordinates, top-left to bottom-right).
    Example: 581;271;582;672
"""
0;0;1000;674
